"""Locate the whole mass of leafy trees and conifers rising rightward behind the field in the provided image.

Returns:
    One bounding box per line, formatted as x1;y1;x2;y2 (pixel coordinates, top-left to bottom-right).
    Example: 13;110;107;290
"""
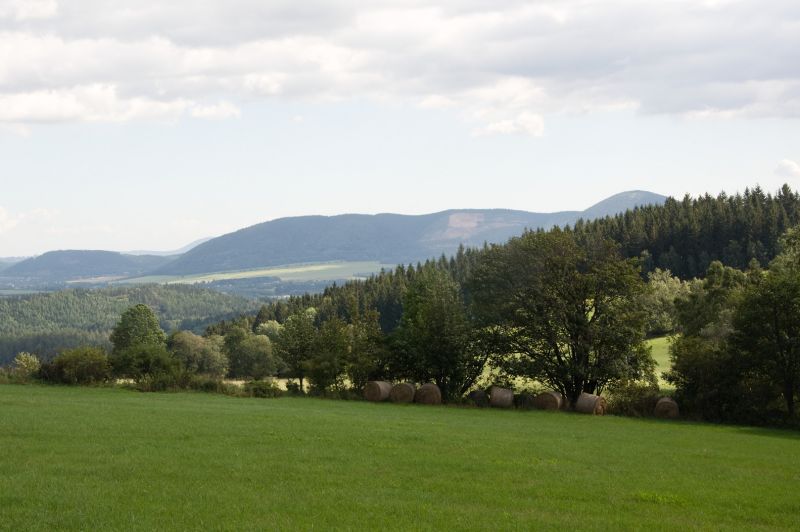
4;186;800;423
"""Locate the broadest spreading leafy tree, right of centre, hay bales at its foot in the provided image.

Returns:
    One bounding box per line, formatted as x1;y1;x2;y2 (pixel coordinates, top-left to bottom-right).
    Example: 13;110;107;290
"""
469;229;655;404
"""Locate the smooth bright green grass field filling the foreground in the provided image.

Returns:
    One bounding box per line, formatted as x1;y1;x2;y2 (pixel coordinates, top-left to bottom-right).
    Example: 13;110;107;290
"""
0;385;800;530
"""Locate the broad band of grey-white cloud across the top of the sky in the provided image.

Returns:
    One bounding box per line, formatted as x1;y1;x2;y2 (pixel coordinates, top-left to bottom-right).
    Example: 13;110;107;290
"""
0;0;800;135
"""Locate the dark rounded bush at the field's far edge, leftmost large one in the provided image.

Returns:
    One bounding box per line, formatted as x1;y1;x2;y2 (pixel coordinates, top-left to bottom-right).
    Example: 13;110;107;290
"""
39;347;111;385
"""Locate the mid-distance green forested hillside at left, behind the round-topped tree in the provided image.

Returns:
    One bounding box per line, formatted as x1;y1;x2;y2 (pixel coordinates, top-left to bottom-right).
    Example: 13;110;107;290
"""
0;285;257;366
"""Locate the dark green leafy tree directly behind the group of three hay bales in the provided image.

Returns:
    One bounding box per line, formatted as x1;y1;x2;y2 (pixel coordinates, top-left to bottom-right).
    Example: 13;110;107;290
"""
392;265;487;400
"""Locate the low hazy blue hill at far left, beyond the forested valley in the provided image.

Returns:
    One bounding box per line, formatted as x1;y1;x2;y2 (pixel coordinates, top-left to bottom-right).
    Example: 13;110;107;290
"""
3;250;172;282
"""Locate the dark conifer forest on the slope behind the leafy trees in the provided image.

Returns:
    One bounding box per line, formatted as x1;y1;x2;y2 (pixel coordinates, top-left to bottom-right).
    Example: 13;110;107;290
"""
244;185;800;332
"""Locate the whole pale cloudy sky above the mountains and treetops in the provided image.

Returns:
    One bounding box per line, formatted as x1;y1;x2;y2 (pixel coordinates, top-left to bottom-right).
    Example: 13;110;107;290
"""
0;0;800;257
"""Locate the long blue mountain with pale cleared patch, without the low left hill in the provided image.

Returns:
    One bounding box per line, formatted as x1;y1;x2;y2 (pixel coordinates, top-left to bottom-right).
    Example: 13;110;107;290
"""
157;191;666;275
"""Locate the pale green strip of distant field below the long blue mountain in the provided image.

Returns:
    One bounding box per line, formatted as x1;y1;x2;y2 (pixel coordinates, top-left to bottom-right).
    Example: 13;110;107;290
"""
119;261;394;284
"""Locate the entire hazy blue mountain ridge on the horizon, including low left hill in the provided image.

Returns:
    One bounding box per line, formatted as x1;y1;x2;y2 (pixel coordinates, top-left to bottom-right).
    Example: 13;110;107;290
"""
0;190;667;283
